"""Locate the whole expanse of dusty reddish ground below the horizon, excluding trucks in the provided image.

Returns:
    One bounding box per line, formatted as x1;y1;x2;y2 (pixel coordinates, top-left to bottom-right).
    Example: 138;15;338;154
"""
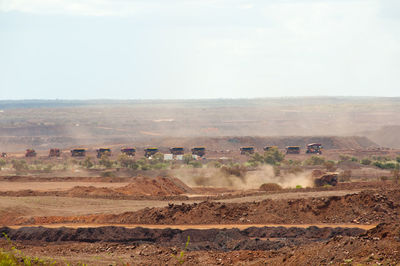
0;98;400;265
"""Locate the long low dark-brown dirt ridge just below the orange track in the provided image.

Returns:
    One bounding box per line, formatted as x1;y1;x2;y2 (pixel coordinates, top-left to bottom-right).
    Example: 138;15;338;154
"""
0;226;365;251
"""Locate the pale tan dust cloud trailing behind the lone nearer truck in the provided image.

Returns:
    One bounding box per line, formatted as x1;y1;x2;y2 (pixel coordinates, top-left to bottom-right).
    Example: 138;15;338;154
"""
173;166;313;189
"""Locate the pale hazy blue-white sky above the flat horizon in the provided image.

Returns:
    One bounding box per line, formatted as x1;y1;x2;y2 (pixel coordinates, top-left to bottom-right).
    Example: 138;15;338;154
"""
0;0;400;100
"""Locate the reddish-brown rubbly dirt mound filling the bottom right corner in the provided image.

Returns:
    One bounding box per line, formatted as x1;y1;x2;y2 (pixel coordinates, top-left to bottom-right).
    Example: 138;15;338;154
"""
272;223;400;265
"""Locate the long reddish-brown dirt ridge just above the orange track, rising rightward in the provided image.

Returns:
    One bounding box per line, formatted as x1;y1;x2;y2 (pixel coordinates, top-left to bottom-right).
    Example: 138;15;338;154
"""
11;190;400;224
